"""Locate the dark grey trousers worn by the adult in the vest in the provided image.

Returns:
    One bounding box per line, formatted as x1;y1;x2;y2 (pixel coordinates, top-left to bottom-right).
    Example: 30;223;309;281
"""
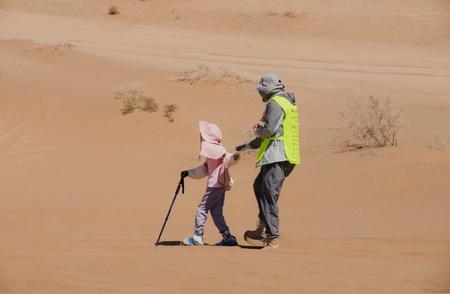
253;161;295;238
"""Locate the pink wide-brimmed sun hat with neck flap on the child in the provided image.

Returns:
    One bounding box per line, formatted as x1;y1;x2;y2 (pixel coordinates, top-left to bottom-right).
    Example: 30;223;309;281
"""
198;121;227;159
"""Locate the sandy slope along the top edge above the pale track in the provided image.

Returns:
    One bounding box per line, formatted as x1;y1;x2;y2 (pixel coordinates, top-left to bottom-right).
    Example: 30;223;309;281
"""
0;0;450;45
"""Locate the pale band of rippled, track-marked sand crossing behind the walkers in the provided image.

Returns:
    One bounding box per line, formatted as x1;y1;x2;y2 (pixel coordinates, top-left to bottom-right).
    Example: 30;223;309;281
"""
0;12;450;79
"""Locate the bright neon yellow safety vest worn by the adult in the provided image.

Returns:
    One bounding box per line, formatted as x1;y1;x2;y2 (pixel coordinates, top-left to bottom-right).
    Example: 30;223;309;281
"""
256;96;300;164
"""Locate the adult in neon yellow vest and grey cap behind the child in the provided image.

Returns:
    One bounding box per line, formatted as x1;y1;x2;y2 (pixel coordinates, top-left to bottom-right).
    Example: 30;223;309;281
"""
236;73;300;249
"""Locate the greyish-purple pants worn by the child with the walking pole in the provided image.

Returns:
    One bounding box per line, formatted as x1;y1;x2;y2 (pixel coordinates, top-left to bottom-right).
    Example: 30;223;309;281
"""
194;187;229;236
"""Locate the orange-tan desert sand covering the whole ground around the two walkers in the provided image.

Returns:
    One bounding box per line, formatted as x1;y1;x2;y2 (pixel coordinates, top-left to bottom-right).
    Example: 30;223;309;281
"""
0;0;450;294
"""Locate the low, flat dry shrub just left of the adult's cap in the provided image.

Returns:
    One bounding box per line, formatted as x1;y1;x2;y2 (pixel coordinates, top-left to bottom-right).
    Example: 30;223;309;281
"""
175;64;251;85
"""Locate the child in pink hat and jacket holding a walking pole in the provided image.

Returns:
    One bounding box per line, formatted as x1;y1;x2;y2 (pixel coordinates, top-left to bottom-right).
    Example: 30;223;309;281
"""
181;121;240;246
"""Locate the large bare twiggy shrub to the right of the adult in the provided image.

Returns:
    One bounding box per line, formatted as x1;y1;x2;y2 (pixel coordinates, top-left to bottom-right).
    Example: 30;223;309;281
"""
336;96;401;151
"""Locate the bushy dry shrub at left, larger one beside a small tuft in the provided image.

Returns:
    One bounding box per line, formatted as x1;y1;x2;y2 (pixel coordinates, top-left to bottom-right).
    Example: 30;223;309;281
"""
115;82;158;114
